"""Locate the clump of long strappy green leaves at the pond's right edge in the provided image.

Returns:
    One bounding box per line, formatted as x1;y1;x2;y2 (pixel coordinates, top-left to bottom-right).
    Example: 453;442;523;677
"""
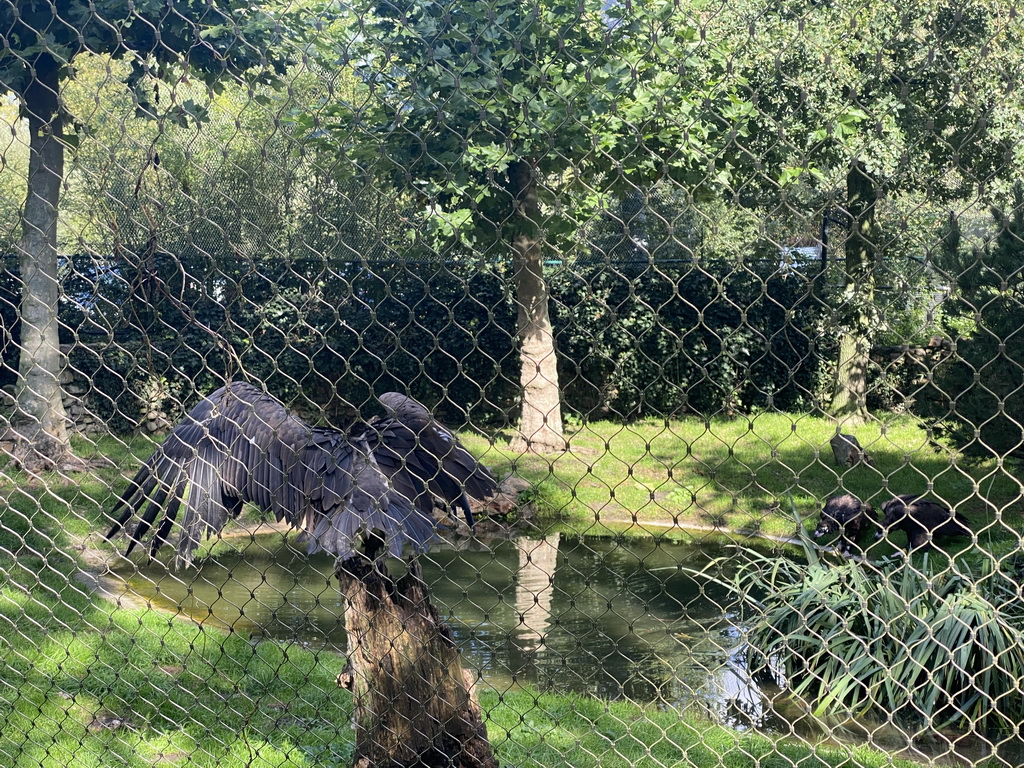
735;554;1024;731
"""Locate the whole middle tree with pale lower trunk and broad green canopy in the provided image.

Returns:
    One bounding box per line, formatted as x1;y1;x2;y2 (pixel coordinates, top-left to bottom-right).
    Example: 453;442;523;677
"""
299;0;743;450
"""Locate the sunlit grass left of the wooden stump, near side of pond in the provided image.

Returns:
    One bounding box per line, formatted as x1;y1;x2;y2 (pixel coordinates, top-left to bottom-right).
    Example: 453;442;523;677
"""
0;477;352;768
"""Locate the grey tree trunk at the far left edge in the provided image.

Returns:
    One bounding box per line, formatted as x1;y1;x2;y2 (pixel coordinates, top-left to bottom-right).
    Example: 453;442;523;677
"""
8;54;72;471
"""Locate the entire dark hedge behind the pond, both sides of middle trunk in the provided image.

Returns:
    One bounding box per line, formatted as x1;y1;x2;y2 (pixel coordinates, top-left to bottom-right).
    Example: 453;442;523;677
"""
70;249;816;430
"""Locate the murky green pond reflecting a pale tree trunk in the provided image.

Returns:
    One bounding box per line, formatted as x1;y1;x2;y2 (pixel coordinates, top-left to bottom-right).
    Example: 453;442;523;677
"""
117;532;1015;762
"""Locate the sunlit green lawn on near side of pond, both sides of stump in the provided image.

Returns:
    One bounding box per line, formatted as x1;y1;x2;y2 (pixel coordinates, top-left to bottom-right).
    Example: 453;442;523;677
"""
0;440;929;768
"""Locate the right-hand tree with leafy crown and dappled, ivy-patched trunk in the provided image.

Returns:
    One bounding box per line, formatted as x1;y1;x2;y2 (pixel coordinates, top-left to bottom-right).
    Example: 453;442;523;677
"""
709;0;1020;420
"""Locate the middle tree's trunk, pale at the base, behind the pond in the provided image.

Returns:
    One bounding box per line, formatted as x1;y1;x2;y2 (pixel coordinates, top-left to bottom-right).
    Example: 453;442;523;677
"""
509;160;566;454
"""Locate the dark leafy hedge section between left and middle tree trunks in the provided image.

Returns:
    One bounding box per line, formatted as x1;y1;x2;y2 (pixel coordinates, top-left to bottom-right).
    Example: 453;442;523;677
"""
75;260;515;427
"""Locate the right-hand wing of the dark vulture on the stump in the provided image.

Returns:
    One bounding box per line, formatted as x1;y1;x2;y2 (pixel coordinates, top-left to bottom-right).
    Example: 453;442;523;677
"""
375;392;498;525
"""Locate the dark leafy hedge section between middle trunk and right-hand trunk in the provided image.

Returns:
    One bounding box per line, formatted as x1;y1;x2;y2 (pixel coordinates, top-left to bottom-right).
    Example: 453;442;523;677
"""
555;258;817;417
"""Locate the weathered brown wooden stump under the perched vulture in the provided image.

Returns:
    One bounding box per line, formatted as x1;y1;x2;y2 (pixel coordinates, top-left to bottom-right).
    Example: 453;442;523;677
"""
336;558;498;768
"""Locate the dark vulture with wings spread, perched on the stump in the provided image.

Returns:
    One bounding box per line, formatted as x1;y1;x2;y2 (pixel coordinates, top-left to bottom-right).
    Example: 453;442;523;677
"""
106;382;497;562
